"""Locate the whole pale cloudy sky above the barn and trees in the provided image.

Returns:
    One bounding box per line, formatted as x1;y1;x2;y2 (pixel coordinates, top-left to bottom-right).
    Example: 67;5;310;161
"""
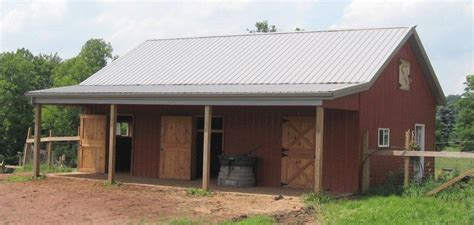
0;0;474;95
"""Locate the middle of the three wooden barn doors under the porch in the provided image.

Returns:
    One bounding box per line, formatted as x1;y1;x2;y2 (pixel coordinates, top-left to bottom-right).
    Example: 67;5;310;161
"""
160;116;193;180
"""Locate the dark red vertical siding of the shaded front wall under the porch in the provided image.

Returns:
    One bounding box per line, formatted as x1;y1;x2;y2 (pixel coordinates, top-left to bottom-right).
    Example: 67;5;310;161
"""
87;105;358;192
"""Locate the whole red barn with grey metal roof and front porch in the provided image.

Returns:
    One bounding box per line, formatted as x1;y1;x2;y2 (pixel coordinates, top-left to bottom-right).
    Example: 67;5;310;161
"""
26;27;445;193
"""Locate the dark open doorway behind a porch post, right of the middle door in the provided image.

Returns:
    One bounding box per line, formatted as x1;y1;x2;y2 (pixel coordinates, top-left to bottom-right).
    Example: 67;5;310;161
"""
196;117;224;178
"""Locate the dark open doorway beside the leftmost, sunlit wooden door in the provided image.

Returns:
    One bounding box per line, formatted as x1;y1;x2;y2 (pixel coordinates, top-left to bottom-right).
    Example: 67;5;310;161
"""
115;115;133;172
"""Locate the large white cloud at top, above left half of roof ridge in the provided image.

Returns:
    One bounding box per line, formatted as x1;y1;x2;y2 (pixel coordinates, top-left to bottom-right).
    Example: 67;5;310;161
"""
95;1;286;54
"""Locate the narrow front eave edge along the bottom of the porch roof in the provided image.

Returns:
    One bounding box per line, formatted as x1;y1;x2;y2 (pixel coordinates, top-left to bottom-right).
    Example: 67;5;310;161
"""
26;92;333;106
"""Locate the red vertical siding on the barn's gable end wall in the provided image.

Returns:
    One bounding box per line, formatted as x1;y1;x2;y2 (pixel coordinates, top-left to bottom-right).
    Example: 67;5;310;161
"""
359;43;436;185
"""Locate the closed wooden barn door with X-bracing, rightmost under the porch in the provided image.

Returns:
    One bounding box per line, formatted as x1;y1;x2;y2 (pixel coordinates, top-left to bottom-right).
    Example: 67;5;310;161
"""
281;117;316;188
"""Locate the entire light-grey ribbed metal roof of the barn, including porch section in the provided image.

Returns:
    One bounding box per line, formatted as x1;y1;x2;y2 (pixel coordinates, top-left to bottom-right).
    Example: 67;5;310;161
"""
27;27;444;105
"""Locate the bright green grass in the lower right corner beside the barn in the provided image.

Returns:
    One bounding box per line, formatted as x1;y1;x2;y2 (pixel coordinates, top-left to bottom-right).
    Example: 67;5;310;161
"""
303;175;474;224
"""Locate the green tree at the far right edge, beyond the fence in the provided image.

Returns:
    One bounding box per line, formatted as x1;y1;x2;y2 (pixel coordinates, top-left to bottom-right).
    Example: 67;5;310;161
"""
456;75;474;151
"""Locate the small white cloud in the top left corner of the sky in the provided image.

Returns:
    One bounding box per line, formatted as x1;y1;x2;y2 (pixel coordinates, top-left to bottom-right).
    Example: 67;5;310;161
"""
0;1;66;33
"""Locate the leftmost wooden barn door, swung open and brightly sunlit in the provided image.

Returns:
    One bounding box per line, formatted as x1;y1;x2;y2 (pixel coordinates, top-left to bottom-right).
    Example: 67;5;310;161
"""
78;114;107;173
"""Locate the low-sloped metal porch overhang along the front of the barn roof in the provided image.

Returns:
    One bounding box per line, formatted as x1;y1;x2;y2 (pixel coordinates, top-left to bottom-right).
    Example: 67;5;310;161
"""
26;83;369;106
